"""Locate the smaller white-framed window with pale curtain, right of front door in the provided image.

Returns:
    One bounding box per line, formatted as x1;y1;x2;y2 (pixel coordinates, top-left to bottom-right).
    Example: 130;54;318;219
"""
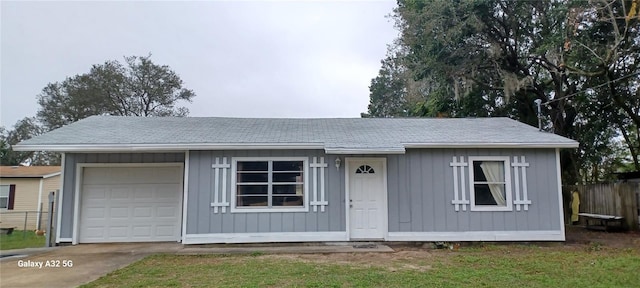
469;157;512;211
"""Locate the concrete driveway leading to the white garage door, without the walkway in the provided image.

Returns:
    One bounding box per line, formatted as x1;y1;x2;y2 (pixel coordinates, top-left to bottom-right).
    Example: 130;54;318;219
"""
0;242;182;287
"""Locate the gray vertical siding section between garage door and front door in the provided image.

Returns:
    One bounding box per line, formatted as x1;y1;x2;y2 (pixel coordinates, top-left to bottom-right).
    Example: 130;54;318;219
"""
187;150;346;234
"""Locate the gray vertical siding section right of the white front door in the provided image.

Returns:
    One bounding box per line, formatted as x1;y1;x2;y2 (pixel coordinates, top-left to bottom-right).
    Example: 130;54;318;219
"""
386;149;561;232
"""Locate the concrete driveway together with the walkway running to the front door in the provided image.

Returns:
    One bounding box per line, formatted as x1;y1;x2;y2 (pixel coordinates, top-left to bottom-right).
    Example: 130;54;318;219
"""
0;243;393;287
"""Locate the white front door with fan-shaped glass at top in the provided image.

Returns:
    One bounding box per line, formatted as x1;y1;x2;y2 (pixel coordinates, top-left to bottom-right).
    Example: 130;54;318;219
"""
346;158;387;240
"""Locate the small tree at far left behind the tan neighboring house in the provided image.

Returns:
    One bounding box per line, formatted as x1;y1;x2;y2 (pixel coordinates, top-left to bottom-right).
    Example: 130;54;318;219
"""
0;117;60;166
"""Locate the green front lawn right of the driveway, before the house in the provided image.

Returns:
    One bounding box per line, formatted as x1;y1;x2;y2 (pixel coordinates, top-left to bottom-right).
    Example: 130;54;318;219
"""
82;245;640;287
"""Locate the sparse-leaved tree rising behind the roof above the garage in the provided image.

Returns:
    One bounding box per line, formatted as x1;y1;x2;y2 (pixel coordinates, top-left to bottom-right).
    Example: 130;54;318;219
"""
37;55;195;130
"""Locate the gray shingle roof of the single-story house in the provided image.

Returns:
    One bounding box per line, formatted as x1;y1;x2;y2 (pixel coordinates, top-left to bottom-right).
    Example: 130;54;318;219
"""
15;116;577;152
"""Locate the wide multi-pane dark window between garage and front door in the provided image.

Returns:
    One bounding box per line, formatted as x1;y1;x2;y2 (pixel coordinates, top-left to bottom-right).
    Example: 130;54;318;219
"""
232;158;306;212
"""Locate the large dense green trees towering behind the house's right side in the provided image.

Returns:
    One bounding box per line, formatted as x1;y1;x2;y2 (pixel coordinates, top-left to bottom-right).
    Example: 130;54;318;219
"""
372;0;640;183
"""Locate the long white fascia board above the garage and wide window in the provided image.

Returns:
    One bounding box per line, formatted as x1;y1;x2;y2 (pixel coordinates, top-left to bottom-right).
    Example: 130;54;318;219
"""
13;143;324;152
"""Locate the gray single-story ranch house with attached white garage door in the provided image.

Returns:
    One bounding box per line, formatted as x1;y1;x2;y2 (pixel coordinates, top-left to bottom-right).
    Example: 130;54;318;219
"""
14;116;578;244
